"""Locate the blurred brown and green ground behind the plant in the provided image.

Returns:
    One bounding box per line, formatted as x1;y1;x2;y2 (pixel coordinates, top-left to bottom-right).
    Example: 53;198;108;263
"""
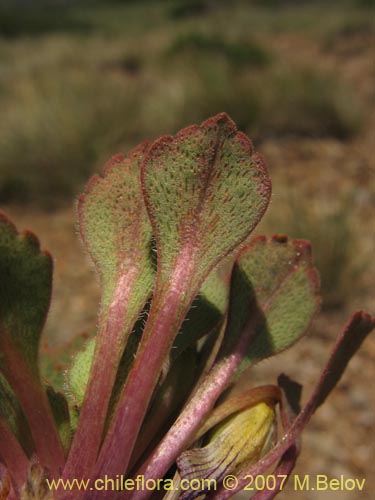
0;0;375;500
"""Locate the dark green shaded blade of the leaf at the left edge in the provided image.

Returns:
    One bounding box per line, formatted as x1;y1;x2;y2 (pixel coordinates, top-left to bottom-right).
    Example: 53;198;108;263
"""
0;214;52;378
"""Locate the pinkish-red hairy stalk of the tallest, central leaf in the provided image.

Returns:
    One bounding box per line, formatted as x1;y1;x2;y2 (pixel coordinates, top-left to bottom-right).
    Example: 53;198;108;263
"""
86;258;194;498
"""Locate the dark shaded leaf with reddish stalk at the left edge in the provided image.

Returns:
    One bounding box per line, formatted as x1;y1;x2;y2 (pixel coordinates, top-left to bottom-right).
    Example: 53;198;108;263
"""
0;214;64;473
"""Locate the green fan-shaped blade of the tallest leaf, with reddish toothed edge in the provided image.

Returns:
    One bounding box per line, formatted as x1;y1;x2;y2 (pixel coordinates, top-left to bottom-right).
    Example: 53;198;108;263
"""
142;113;271;286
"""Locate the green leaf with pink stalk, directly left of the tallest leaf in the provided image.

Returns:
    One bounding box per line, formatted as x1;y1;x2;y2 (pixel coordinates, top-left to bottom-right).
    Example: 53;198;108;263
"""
64;143;155;477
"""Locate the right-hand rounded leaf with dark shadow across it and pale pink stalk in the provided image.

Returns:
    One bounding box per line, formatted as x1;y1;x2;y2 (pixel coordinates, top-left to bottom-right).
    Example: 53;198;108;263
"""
134;236;319;486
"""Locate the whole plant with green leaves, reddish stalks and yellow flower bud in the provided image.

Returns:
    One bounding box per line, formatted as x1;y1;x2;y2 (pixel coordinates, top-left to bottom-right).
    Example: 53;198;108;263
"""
0;113;374;499
